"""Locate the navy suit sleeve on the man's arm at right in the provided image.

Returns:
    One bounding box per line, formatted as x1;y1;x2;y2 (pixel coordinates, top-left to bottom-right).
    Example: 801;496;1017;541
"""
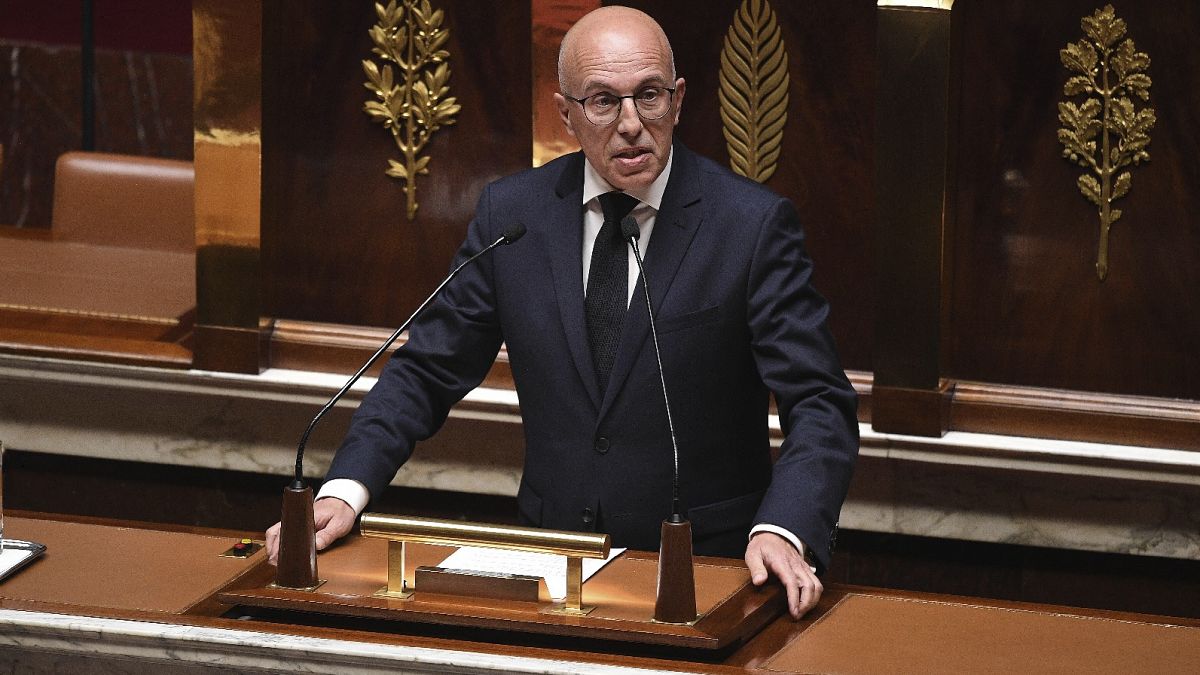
746;199;858;571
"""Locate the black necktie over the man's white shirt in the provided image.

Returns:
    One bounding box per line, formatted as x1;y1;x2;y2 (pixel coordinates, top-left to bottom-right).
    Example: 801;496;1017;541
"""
583;192;638;394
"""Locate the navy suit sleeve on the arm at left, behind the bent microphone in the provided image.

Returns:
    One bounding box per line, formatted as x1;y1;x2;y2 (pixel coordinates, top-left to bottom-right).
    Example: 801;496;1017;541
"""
325;183;503;498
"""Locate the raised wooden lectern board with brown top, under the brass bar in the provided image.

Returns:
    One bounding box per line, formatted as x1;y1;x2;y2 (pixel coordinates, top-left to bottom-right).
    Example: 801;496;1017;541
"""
217;538;786;650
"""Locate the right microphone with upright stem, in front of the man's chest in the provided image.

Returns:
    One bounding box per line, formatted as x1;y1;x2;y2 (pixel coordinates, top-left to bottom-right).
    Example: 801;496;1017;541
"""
620;216;696;623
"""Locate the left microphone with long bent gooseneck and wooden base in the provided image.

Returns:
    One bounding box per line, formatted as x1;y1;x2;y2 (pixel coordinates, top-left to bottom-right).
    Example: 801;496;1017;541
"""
275;223;526;590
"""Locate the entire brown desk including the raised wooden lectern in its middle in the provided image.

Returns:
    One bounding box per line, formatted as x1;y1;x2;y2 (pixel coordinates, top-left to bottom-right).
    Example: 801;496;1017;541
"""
0;514;1200;675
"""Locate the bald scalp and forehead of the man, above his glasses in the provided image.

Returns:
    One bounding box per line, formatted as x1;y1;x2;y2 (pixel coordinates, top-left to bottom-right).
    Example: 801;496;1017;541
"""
558;5;674;96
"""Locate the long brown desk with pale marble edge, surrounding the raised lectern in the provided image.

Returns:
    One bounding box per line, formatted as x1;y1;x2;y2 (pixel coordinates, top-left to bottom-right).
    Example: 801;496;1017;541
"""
0;514;1200;674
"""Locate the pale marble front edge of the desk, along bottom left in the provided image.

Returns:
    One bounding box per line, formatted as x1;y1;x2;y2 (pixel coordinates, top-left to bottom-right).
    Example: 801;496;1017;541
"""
0;609;673;675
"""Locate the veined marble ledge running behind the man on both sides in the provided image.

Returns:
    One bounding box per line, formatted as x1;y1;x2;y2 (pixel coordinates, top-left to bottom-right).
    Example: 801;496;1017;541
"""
0;356;1200;560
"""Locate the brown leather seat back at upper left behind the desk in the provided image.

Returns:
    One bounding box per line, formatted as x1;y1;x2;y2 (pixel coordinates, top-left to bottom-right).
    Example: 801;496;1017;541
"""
50;153;196;252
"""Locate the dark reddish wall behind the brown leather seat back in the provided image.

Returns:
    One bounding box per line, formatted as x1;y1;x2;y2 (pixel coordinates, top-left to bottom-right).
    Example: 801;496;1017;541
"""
0;0;192;227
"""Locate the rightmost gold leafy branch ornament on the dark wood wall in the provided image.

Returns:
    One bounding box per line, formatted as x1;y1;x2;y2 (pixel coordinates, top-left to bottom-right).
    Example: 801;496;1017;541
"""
1058;5;1156;281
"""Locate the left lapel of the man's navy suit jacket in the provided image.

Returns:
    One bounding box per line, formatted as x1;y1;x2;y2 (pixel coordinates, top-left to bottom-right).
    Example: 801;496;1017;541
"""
546;153;600;408
